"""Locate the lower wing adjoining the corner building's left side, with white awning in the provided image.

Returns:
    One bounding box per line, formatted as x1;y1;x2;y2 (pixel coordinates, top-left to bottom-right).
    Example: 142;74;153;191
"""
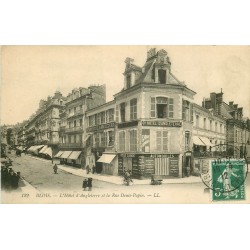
86;101;115;175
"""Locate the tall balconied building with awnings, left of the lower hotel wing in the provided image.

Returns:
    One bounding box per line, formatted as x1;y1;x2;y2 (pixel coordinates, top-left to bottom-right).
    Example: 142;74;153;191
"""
56;85;106;167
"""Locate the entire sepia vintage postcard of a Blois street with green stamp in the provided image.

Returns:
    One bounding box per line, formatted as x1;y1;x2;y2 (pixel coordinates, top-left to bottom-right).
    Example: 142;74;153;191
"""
0;45;250;204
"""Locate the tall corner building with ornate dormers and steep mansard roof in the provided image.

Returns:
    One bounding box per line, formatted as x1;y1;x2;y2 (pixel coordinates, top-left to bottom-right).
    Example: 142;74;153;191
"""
87;49;196;178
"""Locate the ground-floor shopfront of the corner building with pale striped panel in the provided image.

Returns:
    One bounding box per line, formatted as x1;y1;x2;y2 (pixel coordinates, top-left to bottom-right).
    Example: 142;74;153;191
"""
118;154;181;179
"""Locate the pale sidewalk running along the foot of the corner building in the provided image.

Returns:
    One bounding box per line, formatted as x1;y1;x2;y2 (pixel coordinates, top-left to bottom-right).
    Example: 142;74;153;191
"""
58;165;202;185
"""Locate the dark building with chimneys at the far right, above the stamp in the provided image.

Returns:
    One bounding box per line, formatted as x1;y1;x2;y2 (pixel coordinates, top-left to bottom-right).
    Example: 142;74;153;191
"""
202;91;250;158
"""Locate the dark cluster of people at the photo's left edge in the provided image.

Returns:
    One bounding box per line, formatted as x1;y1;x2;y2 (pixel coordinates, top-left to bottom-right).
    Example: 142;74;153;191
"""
1;166;21;191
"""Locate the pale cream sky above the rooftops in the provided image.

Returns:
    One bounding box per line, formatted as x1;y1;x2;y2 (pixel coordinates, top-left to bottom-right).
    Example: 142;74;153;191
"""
0;45;250;125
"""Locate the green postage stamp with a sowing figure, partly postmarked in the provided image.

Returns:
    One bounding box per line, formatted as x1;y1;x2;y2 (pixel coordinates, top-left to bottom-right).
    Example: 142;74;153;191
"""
210;159;247;201
